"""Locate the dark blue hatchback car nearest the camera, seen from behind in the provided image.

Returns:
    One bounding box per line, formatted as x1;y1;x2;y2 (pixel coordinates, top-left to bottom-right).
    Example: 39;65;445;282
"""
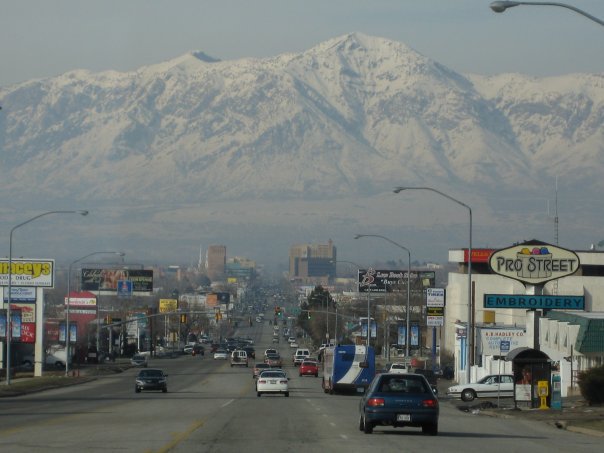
359;373;439;436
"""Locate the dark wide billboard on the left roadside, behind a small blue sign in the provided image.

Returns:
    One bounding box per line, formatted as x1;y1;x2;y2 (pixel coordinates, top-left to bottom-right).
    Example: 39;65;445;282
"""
81;269;153;296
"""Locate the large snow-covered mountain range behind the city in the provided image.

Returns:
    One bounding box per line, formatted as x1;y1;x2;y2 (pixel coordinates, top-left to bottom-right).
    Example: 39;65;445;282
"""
0;33;604;268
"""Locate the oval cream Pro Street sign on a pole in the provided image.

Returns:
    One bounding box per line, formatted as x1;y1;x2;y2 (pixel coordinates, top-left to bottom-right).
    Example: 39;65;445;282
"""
489;240;581;285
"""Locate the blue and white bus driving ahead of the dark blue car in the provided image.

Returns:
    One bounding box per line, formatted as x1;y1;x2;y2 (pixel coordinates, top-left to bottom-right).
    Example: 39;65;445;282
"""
322;344;375;394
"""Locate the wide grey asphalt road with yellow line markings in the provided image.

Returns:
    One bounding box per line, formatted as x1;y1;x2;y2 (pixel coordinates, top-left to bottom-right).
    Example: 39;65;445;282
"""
0;324;601;453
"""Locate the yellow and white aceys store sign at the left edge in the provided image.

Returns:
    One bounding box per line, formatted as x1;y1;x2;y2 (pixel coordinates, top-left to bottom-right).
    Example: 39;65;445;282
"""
0;259;55;286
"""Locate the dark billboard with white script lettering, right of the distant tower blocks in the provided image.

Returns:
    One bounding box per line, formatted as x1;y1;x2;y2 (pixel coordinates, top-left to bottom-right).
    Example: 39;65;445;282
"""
358;268;436;293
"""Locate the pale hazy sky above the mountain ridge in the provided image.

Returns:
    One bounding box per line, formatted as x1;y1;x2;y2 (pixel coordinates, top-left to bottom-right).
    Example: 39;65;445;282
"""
0;0;604;86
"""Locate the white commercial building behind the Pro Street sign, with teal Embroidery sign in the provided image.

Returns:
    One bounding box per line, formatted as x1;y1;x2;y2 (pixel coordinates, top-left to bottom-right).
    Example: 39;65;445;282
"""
440;242;604;395
